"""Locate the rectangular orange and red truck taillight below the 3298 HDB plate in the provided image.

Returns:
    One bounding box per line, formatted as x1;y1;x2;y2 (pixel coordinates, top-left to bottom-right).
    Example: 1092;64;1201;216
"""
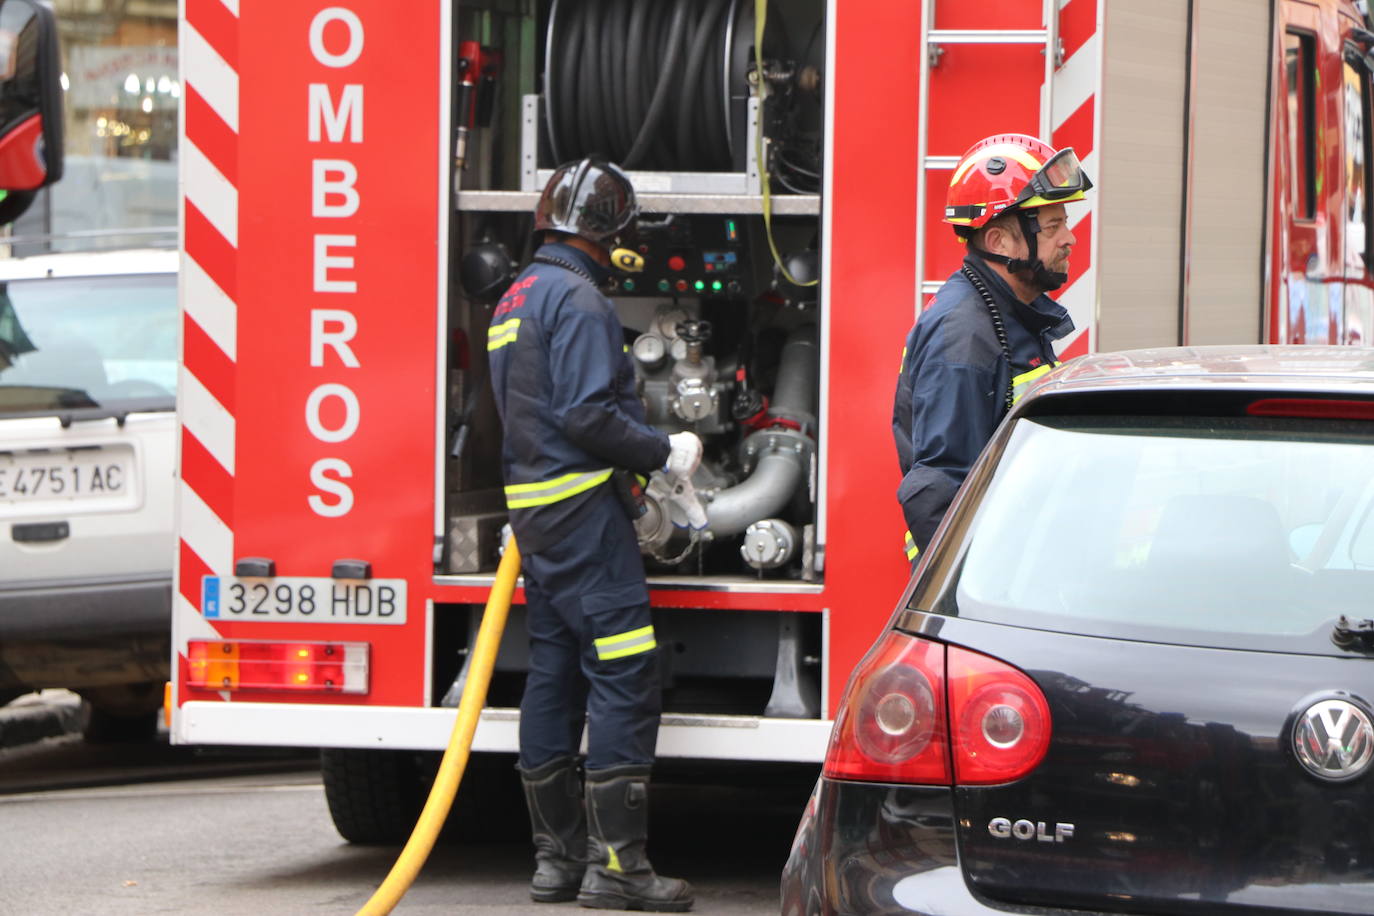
185;640;368;694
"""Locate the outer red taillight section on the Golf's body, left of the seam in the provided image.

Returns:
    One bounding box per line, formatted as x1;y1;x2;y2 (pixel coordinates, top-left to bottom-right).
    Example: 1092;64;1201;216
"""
823;630;949;786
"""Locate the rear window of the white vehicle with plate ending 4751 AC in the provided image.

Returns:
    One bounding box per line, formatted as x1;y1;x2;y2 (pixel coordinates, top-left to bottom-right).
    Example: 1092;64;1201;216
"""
0;273;177;413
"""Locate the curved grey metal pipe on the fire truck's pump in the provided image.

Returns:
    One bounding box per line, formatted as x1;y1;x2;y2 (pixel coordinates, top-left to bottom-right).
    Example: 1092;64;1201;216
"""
706;324;820;537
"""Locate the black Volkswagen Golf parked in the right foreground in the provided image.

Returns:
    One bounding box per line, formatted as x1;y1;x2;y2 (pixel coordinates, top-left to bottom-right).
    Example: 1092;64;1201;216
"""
782;347;1374;916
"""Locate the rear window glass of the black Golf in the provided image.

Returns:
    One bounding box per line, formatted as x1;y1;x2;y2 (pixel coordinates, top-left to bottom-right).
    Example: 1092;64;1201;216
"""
947;415;1374;654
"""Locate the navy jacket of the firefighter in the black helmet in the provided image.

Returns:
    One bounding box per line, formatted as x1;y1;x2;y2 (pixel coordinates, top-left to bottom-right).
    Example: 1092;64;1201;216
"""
486;243;669;552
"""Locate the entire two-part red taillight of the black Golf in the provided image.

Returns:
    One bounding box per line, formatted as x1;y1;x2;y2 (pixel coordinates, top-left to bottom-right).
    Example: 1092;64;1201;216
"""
823;630;1051;786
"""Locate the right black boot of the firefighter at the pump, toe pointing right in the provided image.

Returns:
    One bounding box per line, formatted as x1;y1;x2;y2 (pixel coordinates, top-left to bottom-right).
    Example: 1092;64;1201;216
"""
577;766;692;913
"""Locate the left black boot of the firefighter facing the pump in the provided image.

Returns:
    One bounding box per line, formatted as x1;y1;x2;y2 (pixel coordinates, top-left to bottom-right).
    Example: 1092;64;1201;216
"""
519;757;587;904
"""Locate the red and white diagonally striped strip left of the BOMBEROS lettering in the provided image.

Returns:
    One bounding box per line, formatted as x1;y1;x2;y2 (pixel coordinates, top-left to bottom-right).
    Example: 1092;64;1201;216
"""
173;0;239;655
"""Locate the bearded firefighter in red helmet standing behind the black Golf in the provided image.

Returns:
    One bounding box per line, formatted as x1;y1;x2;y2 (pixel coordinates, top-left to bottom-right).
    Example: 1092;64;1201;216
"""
892;133;1092;564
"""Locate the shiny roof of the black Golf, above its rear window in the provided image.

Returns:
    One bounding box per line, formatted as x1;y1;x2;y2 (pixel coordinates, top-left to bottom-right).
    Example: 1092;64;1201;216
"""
1022;345;1374;402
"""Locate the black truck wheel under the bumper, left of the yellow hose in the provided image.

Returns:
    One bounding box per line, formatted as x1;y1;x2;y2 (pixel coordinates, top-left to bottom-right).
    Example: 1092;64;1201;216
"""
320;747;429;845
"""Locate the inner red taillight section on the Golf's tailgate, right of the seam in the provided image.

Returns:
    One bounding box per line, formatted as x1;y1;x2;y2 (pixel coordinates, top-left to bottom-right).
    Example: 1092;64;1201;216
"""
948;645;1050;786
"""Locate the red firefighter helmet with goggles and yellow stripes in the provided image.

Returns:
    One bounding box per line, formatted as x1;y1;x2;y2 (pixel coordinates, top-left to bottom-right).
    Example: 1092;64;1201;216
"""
944;133;1092;235
